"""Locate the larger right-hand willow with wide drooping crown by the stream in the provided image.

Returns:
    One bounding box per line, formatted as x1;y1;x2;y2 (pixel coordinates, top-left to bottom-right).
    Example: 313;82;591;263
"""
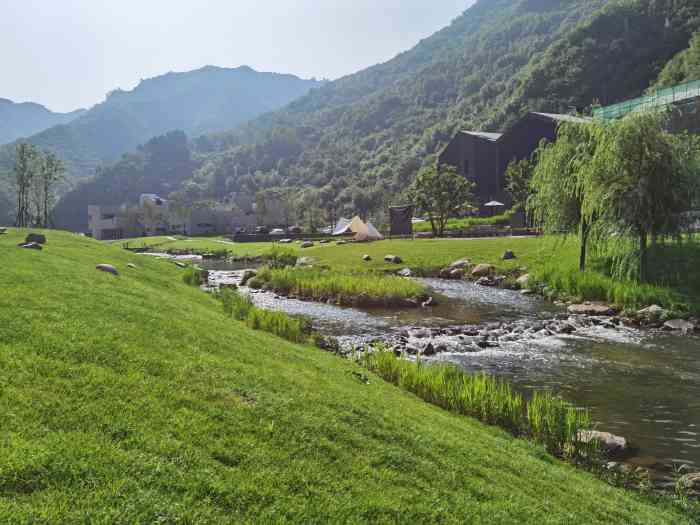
583;113;697;282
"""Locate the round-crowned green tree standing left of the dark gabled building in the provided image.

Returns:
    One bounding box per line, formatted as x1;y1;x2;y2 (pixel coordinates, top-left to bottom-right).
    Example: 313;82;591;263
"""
410;165;474;237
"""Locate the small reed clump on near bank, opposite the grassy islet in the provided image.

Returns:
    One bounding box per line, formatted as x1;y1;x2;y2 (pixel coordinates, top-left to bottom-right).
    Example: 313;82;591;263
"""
219;290;311;343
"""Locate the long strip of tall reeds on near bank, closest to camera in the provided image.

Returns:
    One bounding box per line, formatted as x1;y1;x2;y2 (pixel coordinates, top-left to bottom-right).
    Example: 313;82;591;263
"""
358;350;596;459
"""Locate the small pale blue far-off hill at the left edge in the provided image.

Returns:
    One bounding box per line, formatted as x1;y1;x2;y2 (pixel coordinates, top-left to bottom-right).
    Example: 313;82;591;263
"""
0;98;85;144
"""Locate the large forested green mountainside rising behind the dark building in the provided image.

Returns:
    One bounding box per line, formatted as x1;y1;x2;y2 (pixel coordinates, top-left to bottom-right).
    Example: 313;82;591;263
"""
185;0;700;219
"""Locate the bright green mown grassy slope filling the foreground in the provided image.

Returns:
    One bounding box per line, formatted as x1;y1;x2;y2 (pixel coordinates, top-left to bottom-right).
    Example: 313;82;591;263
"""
0;231;684;524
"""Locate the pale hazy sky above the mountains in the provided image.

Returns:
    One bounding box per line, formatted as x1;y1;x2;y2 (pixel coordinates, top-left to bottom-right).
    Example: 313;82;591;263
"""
0;0;471;111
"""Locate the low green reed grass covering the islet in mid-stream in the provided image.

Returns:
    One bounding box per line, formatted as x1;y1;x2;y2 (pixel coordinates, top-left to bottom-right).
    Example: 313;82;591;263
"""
257;268;427;306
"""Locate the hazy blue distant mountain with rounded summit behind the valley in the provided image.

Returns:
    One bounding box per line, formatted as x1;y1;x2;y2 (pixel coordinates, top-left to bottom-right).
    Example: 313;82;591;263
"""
0;66;323;222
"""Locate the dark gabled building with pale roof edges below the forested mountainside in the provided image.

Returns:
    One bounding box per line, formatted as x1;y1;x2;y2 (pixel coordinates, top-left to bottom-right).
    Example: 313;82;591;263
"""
439;113;588;211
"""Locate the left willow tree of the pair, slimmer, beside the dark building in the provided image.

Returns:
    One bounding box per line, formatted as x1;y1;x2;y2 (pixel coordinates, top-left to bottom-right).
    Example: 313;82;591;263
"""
527;122;606;271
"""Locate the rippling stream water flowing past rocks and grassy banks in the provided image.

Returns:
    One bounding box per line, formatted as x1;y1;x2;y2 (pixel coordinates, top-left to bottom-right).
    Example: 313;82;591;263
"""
204;264;700;472
